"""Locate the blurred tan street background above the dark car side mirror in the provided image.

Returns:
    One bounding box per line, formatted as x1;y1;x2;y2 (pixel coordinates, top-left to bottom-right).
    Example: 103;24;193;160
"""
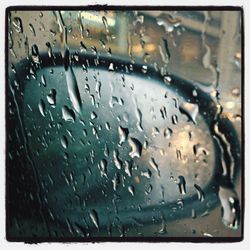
8;10;241;133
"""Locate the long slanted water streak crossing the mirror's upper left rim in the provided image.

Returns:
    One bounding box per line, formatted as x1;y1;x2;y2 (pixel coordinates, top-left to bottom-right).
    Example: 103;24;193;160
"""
64;50;82;113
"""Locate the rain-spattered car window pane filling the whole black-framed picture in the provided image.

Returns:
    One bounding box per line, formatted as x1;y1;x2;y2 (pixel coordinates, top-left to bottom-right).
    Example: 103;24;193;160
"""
6;9;242;241
